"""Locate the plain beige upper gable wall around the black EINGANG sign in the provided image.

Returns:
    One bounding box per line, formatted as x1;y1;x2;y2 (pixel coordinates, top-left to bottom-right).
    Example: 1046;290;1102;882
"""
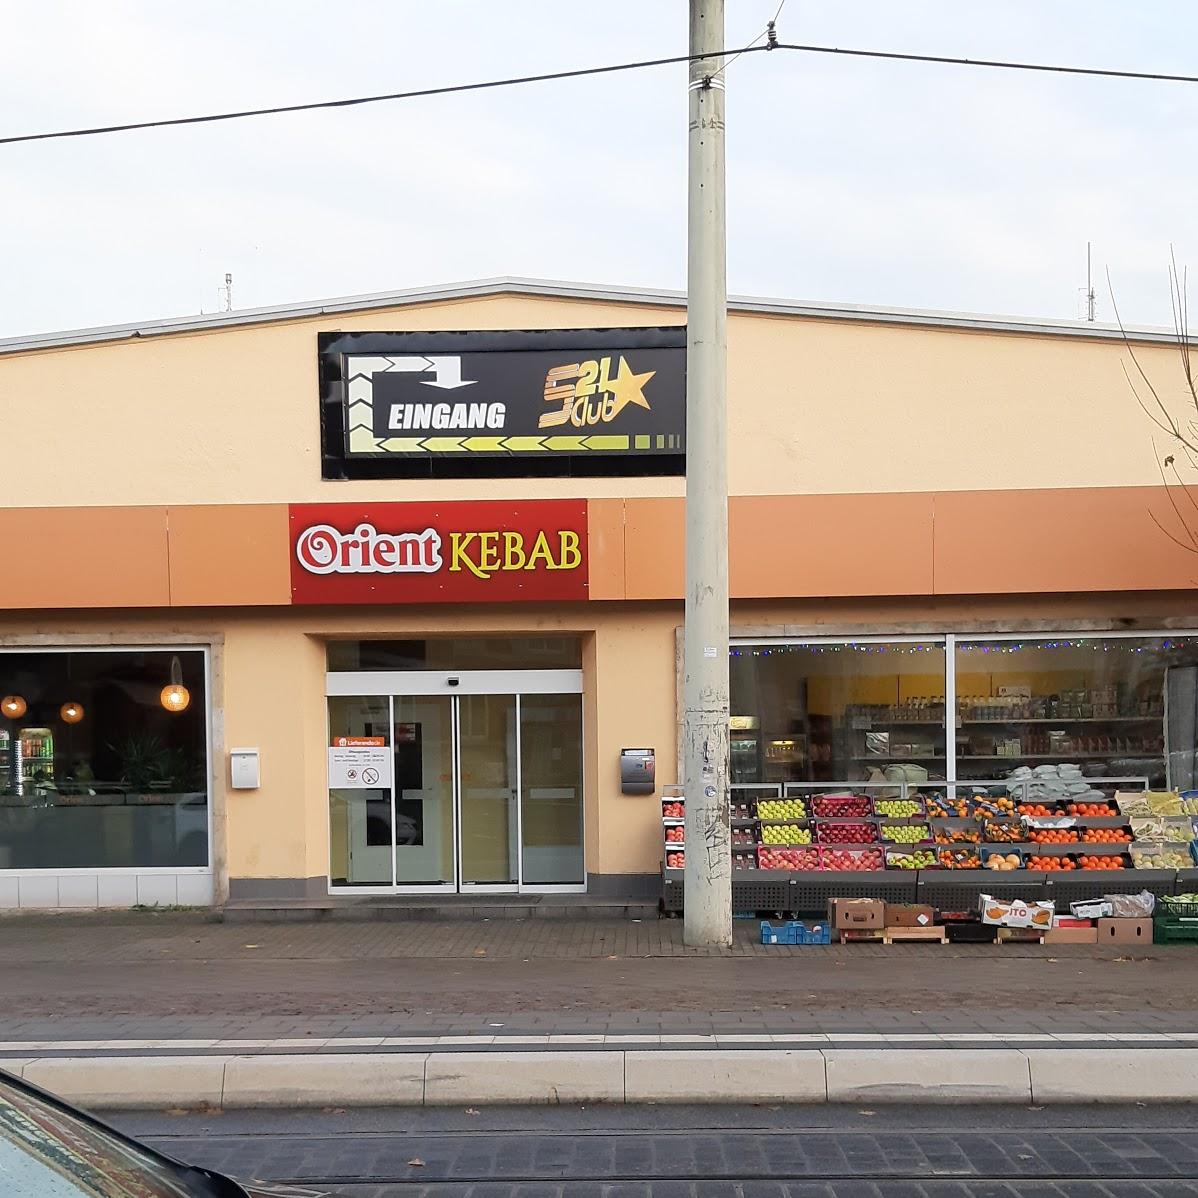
0;295;1182;507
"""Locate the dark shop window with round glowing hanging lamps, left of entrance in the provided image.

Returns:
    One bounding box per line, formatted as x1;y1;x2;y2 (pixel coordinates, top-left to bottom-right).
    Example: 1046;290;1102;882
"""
0;649;208;870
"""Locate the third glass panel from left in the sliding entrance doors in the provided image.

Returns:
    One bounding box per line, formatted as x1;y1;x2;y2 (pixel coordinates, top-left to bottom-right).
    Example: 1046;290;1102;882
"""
456;695;518;885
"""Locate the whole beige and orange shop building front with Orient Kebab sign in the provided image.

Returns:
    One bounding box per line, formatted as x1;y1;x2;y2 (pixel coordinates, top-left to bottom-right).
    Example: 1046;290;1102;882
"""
0;280;1198;907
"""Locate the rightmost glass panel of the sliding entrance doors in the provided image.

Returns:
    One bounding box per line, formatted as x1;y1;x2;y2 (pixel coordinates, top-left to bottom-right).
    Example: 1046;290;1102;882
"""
520;695;586;887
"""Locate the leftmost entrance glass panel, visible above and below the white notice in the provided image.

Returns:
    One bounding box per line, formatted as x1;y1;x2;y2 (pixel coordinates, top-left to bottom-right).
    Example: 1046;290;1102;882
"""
328;696;393;887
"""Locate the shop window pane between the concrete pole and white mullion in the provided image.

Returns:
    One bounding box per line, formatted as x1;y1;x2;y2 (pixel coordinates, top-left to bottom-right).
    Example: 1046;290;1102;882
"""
730;641;948;783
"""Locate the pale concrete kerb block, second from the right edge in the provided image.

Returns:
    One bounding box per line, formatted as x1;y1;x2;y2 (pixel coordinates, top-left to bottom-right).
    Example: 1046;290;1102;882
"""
823;1048;1031;1102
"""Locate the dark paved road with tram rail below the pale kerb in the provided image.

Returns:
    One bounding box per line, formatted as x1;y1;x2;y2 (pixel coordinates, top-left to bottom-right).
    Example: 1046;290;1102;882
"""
110;1107;1198;1198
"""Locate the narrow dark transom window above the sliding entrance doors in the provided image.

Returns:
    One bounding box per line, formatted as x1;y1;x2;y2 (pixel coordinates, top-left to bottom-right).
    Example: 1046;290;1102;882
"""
328;636;582;672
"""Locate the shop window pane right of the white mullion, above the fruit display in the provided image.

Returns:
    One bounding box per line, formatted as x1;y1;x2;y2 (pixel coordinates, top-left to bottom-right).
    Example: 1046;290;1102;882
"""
956;636;1198;789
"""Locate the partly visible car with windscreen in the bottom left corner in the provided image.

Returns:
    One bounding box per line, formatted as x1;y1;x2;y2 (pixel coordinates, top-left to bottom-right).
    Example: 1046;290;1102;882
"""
0;1070;317;1198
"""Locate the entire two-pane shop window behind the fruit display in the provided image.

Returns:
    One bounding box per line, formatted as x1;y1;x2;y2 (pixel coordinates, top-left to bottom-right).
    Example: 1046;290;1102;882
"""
730;634;1198;789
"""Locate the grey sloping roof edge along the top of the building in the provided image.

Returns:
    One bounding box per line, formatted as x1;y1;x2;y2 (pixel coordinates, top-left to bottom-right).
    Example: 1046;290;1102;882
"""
0;276;1176;355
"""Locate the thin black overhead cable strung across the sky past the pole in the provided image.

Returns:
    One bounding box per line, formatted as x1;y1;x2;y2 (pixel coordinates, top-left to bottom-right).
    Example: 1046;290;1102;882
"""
0;37;1198;145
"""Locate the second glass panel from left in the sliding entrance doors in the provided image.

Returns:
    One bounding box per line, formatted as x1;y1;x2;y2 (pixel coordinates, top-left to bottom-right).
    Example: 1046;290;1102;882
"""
393;695;455;887
